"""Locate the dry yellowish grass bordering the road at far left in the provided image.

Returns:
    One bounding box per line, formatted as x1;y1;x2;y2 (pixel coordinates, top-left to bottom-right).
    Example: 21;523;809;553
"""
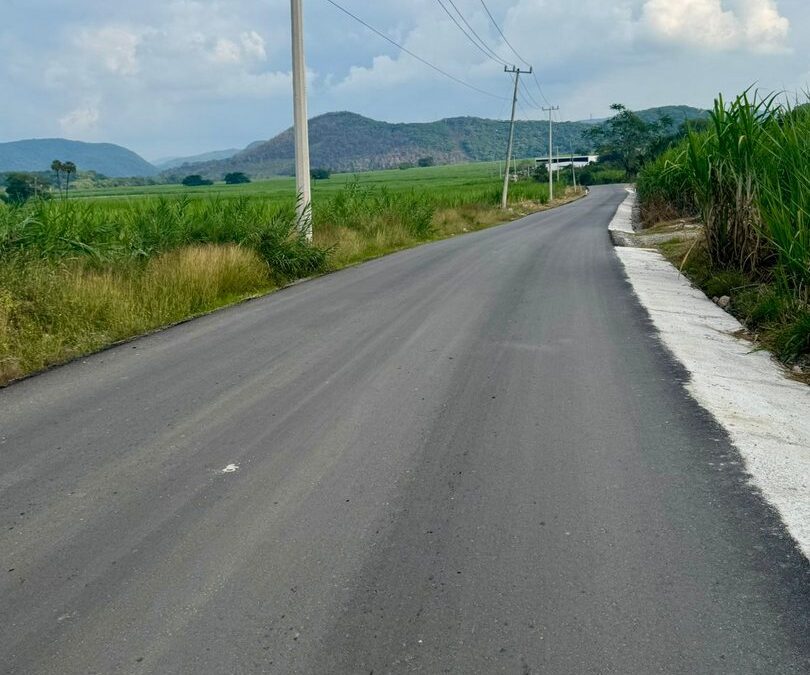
0;244;272;384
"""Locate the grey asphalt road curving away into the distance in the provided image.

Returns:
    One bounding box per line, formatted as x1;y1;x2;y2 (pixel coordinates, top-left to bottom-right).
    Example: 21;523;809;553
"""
0;187;810;675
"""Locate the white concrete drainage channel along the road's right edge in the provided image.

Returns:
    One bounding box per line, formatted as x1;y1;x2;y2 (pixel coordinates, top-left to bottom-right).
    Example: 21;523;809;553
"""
609;188;810;558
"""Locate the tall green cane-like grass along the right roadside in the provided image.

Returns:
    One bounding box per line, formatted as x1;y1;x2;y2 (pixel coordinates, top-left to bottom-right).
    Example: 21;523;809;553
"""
638;92;810;357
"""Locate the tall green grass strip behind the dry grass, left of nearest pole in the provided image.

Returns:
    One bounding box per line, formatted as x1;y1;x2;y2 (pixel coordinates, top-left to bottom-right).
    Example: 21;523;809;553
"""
0;197;326;278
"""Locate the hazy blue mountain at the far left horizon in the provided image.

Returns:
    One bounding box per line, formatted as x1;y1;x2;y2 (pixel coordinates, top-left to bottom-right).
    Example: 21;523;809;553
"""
0;138;158;178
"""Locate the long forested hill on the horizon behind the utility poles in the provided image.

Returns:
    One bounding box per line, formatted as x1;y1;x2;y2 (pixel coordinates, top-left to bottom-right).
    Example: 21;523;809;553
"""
172;106;706;179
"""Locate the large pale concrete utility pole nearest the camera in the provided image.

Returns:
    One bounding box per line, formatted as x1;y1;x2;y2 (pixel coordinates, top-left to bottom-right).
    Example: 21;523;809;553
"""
290;0;312;241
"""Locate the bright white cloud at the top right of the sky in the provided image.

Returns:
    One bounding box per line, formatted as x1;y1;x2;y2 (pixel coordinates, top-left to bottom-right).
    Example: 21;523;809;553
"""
641;0;790;53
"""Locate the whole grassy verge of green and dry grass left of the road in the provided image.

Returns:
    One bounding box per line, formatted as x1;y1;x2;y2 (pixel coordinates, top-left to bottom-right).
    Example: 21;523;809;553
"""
0;176;576;386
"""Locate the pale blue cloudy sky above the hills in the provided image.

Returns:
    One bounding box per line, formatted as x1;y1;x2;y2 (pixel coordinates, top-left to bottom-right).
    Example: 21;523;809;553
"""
0;0;810;160
